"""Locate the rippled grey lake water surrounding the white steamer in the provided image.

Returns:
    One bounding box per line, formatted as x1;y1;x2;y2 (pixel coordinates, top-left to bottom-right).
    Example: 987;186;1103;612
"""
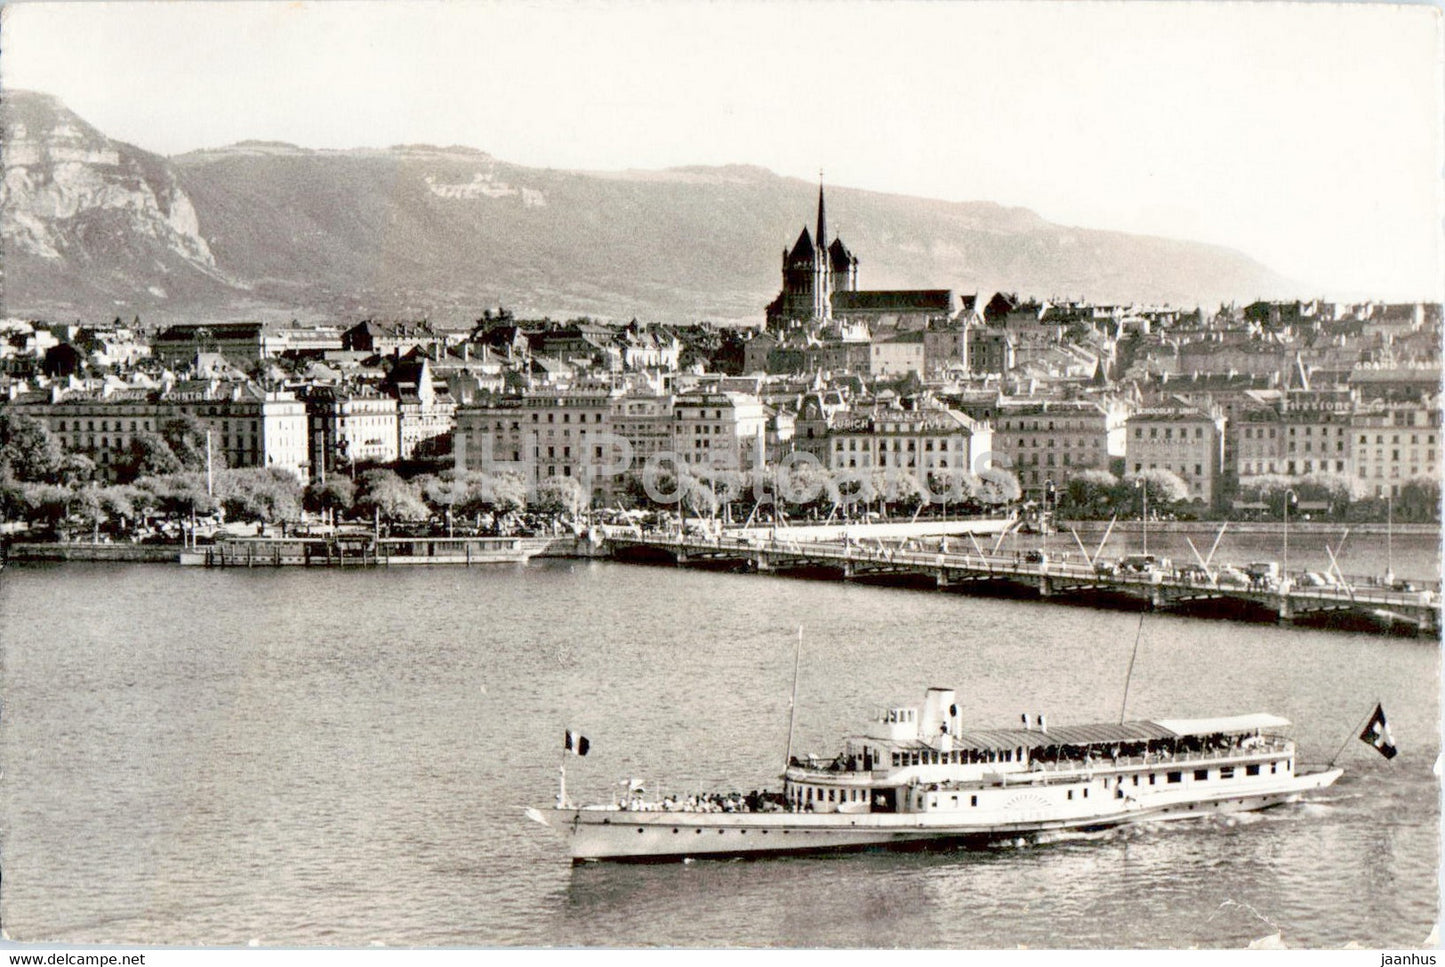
0;561;1439;948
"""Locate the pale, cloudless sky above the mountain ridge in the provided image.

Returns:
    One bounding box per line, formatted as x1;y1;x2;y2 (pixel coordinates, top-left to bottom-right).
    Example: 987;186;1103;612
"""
8;0;1445;301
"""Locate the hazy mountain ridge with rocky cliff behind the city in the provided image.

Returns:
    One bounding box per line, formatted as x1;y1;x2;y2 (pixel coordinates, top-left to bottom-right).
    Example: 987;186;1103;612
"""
0;91;1290;324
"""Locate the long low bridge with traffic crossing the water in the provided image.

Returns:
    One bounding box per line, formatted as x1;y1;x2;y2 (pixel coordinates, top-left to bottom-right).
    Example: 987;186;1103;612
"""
605;535;1441;637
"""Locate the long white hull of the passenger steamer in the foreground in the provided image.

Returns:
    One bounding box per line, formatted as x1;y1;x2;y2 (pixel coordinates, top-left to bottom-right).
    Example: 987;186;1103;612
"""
556;769;1341;863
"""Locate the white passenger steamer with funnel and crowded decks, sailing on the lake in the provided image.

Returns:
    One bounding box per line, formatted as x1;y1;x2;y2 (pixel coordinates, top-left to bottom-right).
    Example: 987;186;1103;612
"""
553;688;1342;863
